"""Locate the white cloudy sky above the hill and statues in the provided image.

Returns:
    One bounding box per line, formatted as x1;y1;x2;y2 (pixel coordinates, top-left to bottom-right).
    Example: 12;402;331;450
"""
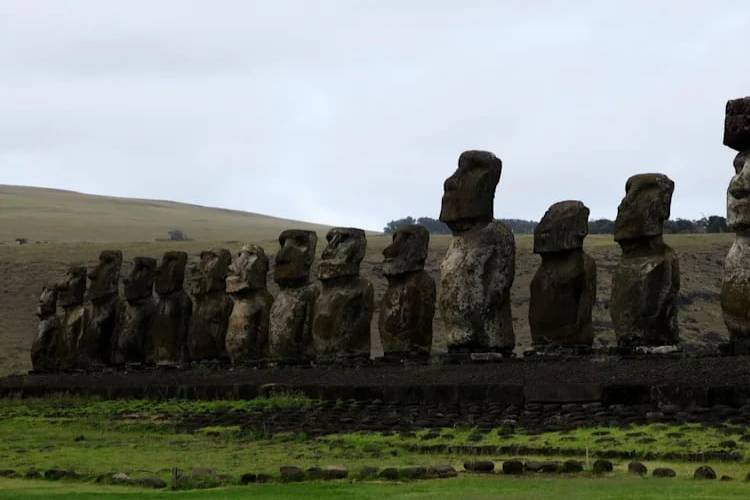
0;0;750;229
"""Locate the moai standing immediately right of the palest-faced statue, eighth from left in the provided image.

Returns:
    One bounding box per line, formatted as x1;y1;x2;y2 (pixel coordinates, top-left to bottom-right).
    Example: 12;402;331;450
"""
269;229;318;363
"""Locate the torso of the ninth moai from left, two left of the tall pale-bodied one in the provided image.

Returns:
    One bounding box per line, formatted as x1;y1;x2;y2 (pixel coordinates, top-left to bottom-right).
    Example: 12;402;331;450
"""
313;276;373;358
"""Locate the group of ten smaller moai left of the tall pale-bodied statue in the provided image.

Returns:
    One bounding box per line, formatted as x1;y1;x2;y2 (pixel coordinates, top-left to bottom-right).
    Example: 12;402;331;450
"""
31;226;435;371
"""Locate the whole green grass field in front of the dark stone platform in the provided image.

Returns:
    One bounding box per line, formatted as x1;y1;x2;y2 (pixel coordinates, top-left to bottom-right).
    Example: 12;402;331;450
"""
0;395;750;499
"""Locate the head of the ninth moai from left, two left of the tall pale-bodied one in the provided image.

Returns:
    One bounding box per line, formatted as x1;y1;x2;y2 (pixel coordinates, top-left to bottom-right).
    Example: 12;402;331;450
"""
318;227;367;280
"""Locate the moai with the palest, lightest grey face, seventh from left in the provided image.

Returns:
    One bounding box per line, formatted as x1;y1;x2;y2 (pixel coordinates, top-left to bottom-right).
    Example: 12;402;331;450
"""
225;245;273;365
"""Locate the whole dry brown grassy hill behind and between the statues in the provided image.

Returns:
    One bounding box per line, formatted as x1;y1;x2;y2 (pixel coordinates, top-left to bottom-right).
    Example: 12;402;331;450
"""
0;186;734;375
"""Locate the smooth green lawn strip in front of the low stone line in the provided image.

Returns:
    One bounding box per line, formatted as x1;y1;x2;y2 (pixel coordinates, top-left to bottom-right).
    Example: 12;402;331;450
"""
0;476;750;500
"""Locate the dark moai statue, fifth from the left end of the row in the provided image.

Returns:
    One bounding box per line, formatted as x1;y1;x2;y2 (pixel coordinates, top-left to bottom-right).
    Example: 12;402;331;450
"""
144;252;193;366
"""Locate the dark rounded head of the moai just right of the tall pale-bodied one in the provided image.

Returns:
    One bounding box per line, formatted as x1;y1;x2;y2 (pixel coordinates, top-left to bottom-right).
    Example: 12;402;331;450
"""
534;201;589;253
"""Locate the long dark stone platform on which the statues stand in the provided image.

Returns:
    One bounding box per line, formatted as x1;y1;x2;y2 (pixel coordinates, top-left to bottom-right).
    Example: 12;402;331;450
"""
0;356;750;408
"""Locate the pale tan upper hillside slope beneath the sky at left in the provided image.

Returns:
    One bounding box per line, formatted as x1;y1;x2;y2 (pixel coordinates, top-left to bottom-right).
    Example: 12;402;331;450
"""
0;185;327;242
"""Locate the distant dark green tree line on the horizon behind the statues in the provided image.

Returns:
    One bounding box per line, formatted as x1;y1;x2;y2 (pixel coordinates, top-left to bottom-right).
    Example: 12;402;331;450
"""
383;215;727;234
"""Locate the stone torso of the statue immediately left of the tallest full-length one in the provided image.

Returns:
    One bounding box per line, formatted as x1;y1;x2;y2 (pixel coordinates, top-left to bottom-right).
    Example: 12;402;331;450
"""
378;271;436;356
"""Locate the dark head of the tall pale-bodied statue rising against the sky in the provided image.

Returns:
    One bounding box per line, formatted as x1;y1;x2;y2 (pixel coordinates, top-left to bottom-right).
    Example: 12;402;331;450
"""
440;151;503;232
